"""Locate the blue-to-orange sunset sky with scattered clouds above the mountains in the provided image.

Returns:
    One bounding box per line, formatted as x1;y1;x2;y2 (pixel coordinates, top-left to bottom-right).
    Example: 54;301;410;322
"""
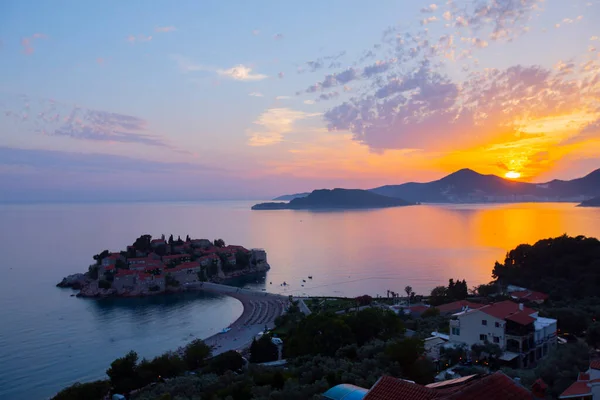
0;0;600;201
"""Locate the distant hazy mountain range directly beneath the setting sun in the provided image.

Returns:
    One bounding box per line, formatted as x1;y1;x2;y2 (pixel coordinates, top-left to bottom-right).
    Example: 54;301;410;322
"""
274;169;600;203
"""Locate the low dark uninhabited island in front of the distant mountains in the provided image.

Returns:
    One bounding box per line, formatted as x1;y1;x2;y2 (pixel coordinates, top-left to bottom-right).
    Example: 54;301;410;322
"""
252;189;414;210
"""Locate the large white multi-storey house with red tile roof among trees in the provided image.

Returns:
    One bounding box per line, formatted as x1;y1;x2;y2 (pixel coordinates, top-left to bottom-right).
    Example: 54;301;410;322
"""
450;300;557;368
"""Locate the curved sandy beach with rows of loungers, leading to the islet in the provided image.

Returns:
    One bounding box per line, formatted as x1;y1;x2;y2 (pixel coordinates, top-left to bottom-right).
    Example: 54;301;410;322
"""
188;282;289;355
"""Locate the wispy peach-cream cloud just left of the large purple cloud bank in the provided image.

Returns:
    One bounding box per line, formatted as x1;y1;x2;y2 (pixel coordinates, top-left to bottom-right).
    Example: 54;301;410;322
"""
246;108;320;146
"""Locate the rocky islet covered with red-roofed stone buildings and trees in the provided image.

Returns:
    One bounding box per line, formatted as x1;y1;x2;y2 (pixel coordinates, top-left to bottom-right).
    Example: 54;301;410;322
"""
57;235;270;297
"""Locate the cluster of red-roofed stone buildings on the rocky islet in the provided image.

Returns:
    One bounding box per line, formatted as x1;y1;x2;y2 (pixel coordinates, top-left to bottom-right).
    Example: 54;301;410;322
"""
98;239;268;294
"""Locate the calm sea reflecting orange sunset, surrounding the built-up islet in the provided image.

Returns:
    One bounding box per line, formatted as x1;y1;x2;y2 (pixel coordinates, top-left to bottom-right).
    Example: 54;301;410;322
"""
0;202;600;400
